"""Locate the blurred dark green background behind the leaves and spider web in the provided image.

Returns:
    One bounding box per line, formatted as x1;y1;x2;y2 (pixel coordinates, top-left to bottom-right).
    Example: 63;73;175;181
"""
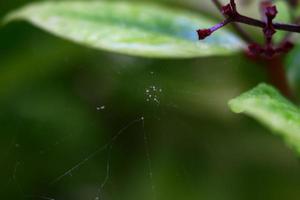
0;0;300;200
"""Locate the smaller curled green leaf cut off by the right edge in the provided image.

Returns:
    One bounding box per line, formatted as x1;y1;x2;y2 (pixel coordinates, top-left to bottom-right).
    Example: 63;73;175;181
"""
229;84;300;153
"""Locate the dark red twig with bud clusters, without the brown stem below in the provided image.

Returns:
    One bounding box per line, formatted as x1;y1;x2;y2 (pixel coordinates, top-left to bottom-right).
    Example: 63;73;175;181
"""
197;0;300;58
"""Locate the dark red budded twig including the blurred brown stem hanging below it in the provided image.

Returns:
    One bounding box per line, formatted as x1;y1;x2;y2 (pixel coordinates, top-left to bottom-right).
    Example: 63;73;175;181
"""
203;0;294;99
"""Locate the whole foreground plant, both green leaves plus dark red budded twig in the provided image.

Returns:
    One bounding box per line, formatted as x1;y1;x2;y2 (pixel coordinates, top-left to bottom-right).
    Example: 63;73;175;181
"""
4;0;300;153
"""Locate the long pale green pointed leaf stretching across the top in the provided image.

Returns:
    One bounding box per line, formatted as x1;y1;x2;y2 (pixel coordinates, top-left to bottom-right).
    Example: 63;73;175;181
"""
5;1;244;58
